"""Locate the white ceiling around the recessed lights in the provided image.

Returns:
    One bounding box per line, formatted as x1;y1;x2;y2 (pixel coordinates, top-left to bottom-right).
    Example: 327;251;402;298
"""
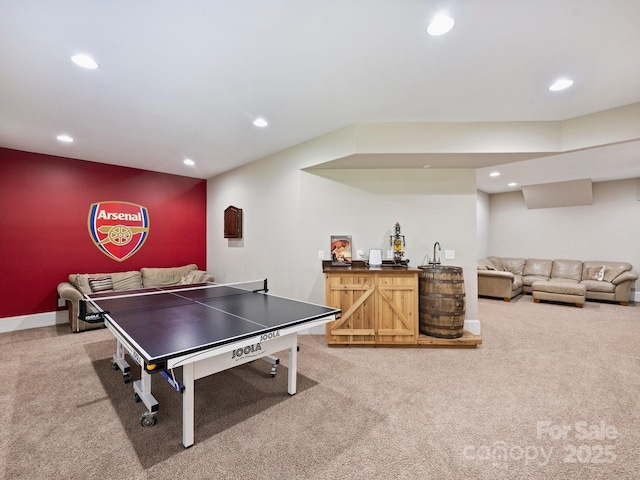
0;0;640;193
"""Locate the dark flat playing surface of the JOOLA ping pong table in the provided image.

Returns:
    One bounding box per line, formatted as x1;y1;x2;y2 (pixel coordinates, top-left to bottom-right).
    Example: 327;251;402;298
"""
87;285;340;363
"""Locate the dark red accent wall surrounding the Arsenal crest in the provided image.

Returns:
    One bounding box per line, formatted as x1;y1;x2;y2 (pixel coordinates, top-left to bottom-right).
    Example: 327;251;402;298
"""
0;148;207;318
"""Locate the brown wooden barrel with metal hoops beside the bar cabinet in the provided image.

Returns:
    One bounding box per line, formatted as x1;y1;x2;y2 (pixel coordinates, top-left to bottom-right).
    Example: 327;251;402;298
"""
418;265;466;338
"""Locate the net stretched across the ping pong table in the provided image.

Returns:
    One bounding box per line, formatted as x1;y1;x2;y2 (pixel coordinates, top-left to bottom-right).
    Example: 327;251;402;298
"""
78;279;268;323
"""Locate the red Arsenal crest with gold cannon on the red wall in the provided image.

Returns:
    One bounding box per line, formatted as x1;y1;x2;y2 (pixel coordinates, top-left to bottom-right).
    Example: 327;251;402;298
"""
89;202;149;262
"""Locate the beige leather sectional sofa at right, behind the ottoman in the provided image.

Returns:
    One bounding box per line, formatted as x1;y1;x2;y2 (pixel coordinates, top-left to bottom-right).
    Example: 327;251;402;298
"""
478;257;638;305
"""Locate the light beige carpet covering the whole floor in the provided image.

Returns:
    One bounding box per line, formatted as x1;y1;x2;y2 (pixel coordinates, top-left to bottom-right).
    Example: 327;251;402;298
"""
0;296;640;480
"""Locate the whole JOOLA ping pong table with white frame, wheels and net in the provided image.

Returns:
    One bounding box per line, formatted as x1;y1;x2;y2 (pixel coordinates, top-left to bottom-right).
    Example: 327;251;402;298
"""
79;280;340;448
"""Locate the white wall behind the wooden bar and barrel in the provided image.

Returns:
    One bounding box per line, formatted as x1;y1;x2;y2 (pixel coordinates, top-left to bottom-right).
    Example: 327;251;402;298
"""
207;152;478;333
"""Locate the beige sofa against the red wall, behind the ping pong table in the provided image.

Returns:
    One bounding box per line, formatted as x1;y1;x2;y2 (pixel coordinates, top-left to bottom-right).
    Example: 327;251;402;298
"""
58;263;213;332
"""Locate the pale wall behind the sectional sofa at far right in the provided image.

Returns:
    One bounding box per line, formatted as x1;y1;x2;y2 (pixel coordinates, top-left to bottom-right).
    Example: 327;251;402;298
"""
483;179;640;288
